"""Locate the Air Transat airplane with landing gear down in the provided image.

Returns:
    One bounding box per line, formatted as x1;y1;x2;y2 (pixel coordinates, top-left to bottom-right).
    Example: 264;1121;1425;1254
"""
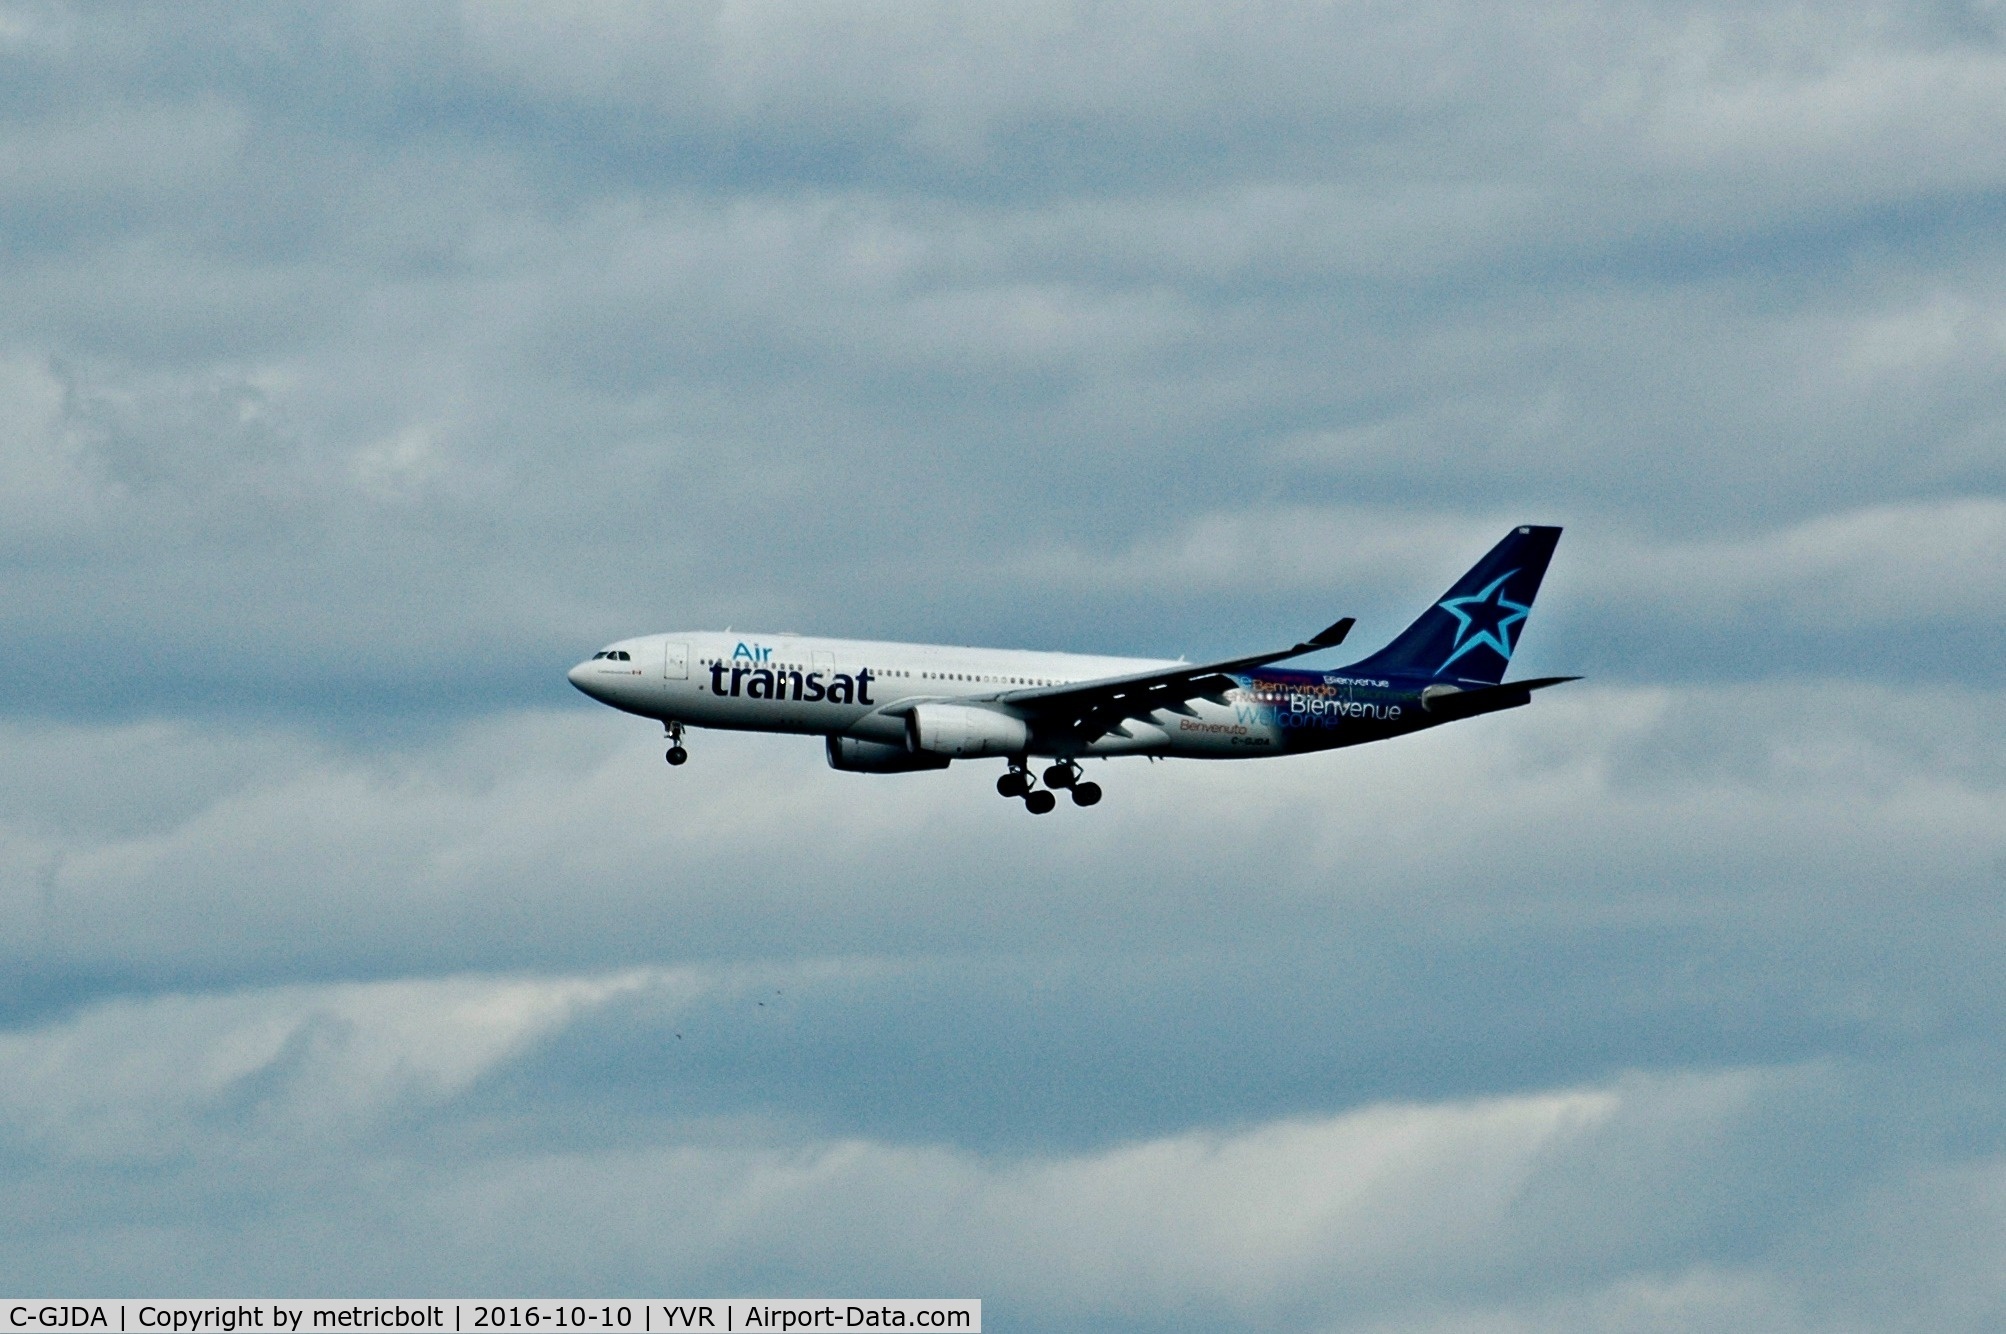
568;526;1581;814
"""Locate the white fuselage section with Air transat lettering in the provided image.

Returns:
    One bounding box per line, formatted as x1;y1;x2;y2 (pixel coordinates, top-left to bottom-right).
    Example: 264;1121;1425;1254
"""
570;632;1280;758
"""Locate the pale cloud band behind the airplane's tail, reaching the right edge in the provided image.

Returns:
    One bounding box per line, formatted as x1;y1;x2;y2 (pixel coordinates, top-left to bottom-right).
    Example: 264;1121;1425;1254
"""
1009;497;2006;682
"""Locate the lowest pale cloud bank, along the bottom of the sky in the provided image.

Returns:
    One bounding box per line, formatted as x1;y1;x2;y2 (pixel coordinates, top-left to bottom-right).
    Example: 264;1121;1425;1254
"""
0;973;2002;1328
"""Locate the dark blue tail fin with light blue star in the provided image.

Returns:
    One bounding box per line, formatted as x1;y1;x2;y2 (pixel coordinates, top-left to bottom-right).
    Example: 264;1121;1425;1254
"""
1344;528;1561;686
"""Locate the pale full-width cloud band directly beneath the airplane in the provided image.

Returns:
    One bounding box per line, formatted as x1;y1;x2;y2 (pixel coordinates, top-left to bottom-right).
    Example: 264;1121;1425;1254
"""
0;684;2006;998
